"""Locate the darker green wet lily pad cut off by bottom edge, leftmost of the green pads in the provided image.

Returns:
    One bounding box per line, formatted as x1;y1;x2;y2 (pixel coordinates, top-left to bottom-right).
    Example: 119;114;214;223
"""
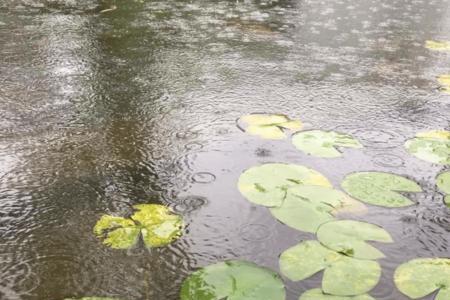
180;260;286;300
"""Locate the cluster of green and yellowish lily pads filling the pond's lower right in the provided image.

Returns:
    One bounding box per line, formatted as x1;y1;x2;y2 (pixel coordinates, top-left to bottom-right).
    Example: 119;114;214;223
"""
180;114;450;300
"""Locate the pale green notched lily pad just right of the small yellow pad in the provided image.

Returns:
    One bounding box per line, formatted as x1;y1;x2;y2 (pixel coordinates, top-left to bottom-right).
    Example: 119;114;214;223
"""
292;130;362;158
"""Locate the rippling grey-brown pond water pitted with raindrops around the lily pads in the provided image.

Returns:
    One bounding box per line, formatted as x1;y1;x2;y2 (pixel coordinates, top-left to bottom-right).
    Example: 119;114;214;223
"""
0;0;450;300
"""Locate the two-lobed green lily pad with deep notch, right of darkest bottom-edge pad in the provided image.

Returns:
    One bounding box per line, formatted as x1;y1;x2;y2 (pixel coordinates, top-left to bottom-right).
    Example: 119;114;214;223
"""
280;241;381;296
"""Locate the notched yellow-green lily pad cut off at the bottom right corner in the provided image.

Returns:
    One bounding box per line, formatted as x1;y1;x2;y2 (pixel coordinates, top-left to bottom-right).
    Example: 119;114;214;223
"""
394;258;450;300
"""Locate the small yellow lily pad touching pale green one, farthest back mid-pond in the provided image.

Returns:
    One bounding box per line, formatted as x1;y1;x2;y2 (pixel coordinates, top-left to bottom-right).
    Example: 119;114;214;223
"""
239;114;303;140
